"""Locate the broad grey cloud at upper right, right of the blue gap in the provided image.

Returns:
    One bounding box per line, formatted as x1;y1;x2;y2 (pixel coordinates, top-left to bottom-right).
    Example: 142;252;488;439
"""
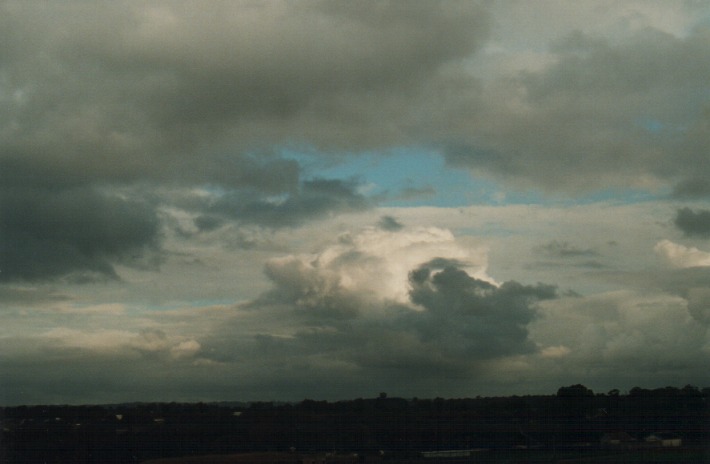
443;28;710;192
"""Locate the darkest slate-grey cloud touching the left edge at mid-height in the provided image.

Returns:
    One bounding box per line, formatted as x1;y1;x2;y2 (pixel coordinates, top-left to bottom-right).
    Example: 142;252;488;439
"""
0;183;159;281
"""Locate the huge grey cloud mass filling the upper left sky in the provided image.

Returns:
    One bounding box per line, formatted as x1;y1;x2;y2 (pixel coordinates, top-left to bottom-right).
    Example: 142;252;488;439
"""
0;1;489;178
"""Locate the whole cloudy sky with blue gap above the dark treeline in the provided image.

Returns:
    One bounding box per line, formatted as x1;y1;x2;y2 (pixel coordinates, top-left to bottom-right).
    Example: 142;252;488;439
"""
0;0;710;405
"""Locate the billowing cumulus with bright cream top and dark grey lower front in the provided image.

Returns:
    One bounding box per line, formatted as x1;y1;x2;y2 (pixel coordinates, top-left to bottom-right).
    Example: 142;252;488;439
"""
229;227;557;389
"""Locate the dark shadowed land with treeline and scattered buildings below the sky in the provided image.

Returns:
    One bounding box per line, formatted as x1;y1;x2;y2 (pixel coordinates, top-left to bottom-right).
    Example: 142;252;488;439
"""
1;384;710;464
